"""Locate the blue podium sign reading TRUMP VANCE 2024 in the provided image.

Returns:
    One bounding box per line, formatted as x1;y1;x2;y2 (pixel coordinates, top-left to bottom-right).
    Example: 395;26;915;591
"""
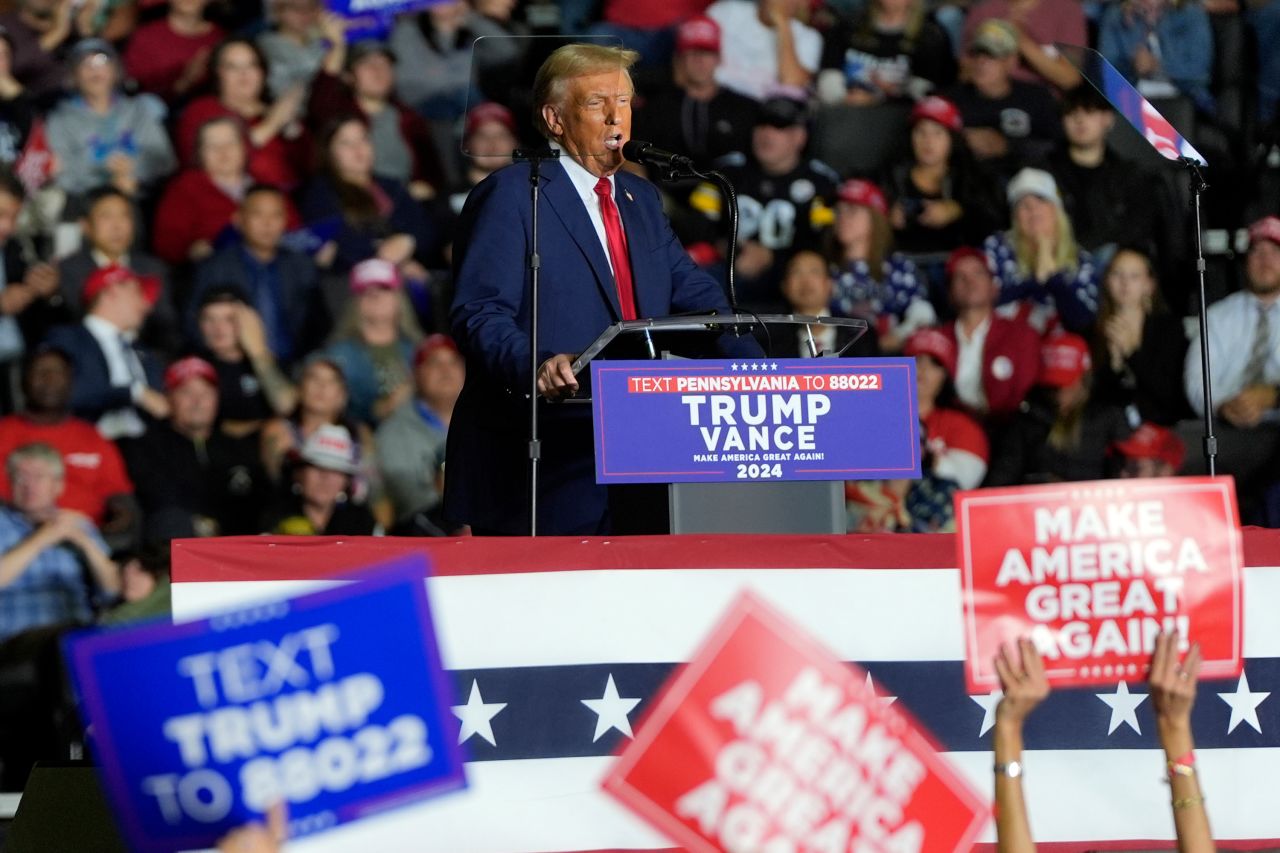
591;359;920;483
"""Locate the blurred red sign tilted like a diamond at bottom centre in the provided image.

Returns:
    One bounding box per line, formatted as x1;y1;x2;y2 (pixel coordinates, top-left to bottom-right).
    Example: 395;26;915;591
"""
604;594;988;853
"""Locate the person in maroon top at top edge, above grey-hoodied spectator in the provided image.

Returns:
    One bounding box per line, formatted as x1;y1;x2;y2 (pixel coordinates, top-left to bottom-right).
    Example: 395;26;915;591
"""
124;0;227;104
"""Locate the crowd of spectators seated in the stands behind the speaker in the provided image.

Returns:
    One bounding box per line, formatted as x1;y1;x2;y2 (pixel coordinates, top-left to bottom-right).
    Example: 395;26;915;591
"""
0;0;1280;783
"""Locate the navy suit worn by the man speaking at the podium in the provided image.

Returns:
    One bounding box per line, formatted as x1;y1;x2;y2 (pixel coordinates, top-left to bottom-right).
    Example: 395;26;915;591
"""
444;163;728;534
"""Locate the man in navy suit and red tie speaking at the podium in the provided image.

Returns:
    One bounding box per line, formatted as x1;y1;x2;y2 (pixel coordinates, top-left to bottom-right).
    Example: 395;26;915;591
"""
444;44;728;535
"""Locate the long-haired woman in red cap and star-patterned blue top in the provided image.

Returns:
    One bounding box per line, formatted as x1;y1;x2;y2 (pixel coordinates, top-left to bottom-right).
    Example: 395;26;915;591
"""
827;178;937;352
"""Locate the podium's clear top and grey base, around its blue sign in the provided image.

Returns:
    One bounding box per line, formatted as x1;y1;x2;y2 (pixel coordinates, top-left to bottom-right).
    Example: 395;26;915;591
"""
572;314;868;534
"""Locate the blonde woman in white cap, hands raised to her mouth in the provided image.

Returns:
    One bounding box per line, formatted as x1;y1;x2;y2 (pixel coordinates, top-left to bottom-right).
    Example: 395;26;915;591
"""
983;169;1098;334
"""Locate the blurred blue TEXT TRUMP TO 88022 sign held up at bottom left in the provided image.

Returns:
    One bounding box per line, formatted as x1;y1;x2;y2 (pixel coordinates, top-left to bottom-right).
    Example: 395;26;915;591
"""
65;556;466;853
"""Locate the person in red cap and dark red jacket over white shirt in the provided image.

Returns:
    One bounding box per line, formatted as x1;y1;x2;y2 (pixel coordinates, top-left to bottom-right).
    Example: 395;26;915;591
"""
942;247;1039;428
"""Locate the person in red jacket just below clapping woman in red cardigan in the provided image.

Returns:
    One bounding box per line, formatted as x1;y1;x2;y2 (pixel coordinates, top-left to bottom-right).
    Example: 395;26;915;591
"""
154;117;301;264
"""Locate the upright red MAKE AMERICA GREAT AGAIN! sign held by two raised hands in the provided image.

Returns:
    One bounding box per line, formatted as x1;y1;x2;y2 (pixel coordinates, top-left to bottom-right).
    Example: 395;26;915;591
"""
955;478;1243;693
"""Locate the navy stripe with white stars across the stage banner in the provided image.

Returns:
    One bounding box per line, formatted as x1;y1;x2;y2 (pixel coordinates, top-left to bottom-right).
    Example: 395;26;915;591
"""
452;650;1280;761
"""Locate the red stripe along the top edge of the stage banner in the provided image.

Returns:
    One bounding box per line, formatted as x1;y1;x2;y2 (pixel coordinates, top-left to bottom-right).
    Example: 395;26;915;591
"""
173;528;1280;583
